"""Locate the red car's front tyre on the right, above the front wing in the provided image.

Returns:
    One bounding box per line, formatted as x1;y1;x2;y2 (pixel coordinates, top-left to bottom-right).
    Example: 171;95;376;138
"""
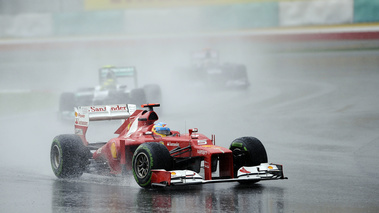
229;137;268;177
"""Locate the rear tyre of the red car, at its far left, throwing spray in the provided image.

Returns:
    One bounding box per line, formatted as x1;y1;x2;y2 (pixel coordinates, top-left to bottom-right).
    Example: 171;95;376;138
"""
50;134;91;178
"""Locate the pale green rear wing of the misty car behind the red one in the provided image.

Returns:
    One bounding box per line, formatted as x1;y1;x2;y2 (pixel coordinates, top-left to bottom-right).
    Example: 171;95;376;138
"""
99;66;138;87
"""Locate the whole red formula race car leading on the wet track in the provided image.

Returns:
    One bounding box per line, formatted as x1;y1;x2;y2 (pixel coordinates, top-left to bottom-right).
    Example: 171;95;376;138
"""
50;104;286;187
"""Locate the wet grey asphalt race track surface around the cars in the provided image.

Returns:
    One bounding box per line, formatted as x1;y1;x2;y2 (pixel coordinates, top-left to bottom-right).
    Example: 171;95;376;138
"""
0;36;379;212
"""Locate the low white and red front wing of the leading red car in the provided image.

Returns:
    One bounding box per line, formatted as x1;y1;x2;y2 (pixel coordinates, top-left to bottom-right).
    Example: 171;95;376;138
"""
151;163;287;187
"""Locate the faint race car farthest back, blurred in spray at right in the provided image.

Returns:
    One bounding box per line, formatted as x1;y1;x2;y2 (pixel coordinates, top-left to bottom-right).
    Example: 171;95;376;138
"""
183;49;250;89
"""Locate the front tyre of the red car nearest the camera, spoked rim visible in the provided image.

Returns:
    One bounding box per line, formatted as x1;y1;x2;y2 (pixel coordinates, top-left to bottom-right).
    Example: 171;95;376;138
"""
132;142;172;188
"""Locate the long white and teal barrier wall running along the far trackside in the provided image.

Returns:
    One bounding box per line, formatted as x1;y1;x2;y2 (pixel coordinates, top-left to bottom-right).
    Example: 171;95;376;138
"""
0;0;379;38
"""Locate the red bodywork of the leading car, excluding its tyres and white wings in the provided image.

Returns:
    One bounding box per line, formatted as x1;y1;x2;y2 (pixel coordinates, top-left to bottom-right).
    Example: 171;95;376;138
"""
75;105;234;182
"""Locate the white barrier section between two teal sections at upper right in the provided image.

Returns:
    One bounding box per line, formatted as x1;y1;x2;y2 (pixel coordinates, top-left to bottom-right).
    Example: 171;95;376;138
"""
279;0;354;26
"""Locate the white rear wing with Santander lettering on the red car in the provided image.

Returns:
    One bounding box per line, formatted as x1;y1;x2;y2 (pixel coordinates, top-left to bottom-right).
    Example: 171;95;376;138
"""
75;104;137;127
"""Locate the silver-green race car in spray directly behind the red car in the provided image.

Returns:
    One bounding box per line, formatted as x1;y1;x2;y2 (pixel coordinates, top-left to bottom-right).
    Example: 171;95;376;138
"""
59;66;161;119
